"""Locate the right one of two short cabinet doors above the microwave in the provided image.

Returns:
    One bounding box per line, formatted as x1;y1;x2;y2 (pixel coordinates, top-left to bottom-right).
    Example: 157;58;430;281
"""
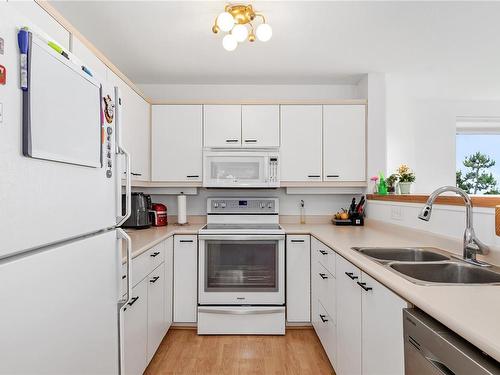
241;105;280;147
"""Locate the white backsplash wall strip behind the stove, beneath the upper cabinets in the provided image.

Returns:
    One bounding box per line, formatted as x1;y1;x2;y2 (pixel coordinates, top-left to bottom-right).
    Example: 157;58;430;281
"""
152;188;359;215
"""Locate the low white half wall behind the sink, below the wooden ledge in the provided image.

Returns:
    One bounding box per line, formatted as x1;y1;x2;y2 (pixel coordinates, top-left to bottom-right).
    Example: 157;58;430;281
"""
366;201;500;265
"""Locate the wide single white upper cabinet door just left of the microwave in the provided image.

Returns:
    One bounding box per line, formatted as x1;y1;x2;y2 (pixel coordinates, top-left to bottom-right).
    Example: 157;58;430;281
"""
151;105;203;182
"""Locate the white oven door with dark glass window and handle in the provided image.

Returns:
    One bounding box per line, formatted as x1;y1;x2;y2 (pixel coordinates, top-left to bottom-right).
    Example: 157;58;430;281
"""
198;235;285;305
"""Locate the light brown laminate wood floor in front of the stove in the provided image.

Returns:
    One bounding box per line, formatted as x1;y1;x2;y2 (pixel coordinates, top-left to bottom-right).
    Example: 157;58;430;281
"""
145;329;335;375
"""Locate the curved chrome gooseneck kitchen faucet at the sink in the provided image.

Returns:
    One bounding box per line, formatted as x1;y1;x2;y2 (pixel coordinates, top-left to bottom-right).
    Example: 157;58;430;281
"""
418;186;490;267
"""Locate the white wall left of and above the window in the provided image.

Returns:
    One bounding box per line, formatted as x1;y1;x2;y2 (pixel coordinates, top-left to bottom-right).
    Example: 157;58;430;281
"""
386;74;500;193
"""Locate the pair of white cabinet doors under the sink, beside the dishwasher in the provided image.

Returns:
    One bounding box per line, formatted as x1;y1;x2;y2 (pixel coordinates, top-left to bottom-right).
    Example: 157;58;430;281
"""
335;256;408;375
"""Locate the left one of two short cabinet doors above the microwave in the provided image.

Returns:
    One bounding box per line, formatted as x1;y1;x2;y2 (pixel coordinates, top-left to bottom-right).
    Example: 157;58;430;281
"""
204;105;241;147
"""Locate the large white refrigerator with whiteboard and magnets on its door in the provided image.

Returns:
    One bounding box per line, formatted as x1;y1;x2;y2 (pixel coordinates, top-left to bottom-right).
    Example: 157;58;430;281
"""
0;8;131;374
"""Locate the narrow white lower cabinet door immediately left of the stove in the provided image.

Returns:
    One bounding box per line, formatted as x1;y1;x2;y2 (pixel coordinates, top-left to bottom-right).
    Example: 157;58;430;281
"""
174;235;198;323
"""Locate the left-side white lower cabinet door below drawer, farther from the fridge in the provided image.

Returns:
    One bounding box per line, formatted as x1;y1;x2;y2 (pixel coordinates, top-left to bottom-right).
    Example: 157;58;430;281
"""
146;263;165;362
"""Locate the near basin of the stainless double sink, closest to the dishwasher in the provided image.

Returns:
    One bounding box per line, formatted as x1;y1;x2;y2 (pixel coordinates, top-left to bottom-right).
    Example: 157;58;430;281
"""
389;262;500;284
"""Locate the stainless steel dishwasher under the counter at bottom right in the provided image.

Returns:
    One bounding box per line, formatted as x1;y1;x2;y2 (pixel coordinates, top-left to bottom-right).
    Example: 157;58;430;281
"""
403;309;500;375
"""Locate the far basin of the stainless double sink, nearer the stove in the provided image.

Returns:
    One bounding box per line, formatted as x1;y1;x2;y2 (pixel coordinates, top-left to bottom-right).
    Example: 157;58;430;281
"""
353;247;450;262
